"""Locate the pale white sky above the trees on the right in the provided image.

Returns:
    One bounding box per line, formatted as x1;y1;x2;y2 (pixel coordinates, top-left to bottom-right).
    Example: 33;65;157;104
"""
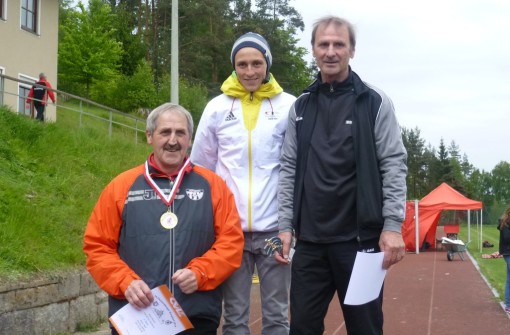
289;0;510;172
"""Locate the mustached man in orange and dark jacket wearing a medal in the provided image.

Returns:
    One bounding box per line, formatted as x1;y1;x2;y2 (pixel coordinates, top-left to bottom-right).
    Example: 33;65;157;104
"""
84;103;244;335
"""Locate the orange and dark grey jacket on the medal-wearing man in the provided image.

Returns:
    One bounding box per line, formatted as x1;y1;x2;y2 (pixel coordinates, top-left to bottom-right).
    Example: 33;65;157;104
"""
84;158;244;322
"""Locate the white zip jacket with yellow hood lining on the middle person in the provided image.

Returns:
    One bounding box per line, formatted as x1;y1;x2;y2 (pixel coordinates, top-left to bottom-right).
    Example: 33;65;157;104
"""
191;72;296;232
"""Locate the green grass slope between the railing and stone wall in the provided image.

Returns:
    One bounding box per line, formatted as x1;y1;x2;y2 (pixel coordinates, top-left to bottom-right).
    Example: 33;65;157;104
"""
0;103;151;279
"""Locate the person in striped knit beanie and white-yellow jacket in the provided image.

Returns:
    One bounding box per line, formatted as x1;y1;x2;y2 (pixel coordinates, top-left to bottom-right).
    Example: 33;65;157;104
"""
191;32;296;335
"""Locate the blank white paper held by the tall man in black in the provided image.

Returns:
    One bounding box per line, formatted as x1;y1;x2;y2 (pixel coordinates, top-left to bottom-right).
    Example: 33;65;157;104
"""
344;252;386;305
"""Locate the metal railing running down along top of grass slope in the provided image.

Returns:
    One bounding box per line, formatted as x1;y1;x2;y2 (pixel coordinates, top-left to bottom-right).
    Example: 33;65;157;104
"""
0;74;146;143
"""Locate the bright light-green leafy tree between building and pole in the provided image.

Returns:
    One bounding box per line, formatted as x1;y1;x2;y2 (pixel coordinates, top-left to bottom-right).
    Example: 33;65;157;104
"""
58;0;123;98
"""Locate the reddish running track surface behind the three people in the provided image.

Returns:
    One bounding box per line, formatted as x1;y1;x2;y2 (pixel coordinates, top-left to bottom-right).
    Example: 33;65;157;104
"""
75;250;510;335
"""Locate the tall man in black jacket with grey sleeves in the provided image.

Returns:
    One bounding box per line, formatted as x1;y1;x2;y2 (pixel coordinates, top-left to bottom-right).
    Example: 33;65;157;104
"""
275;16;407;335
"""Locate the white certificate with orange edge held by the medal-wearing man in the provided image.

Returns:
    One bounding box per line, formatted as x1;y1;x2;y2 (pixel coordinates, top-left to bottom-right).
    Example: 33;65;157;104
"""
110;285;193;335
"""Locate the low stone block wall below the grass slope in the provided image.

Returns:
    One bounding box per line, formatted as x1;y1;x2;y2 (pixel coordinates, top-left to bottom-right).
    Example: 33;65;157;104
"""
0;270;108;335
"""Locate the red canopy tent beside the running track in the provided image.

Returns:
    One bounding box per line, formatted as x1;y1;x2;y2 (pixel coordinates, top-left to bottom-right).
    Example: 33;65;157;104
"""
402;183;482;251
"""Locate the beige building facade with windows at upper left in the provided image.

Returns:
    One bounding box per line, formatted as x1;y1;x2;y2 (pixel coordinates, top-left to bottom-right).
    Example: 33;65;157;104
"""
0;0;59;121
